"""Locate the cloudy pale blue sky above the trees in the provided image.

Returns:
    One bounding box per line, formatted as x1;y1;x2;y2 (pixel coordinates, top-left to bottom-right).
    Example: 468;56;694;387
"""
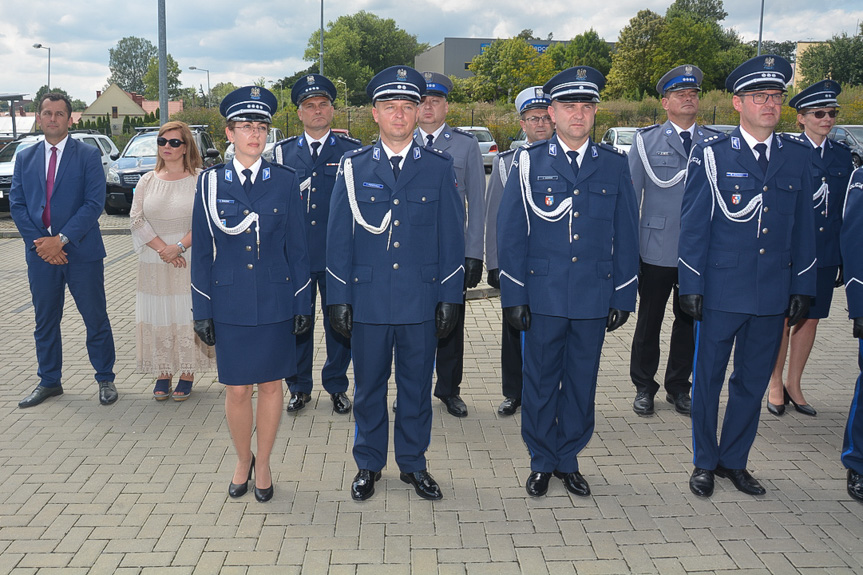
0;0;863;104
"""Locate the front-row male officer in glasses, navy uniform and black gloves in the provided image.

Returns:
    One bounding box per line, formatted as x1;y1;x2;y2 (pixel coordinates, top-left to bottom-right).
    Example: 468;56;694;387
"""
678;55;816;497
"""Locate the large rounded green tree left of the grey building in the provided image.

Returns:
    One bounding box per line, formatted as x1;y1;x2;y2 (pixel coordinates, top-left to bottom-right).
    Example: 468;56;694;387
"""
303;11;428;104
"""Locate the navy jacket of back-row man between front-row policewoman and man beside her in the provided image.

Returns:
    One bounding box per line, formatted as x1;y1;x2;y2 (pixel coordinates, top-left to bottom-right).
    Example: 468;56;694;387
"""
274;131;362;272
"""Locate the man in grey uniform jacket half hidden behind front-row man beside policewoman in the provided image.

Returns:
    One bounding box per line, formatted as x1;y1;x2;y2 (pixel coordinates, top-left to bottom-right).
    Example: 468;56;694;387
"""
414;72;485;417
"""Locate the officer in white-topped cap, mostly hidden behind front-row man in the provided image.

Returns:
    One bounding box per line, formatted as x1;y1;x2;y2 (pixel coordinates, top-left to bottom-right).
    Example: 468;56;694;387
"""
485;86;554;415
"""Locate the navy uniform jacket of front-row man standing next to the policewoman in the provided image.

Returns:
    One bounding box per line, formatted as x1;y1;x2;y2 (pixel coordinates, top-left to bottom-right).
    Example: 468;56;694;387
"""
327;143;464;325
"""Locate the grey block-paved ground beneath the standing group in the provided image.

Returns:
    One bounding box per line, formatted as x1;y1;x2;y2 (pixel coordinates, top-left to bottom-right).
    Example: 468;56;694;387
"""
0;214;863;575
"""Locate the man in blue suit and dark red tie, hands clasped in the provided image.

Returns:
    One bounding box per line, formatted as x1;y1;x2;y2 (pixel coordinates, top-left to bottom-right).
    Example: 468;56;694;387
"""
9;92;117;408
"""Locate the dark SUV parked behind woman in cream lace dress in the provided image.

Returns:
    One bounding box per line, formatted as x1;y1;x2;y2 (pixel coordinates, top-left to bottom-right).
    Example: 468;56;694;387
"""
105;125;222;215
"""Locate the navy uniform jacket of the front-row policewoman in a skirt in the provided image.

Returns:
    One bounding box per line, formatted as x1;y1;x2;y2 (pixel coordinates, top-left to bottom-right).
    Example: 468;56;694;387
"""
192;160;312;326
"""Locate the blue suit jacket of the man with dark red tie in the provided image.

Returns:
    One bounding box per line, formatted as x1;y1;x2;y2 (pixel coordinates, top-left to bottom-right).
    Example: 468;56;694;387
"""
9;137;105;264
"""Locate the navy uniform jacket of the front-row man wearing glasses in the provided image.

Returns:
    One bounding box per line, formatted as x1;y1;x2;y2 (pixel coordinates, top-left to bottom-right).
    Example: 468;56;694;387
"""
678;127;816;315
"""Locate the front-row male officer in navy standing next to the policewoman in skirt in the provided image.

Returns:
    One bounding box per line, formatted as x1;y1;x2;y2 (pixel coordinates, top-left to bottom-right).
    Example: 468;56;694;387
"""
327;66;464;501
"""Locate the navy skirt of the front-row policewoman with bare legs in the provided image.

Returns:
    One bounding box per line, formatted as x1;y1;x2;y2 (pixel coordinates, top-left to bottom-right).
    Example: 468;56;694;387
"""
214;321;297;385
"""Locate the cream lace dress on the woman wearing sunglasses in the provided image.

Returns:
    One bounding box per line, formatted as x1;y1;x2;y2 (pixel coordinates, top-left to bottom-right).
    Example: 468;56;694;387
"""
129;172;215;376
